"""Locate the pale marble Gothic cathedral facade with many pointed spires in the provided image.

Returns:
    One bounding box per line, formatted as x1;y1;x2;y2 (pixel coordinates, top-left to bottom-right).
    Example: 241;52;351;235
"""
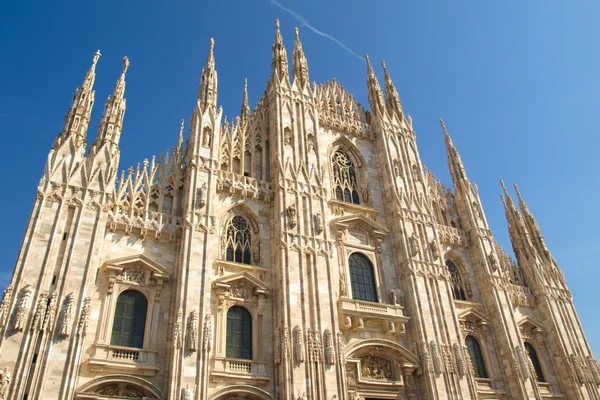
0;21;600;400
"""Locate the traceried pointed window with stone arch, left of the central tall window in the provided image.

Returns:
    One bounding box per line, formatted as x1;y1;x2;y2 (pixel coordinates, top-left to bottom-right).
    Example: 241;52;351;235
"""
220;204;261;265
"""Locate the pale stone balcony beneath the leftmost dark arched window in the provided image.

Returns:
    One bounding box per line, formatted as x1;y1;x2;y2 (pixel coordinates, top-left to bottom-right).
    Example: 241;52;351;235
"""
87;343;160;376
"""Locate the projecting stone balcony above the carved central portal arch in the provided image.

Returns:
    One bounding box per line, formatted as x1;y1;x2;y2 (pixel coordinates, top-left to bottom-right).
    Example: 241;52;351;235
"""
338;297;410;334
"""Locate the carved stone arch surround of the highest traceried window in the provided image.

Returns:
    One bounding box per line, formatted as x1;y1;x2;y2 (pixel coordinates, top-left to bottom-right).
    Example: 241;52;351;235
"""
328;137;371;206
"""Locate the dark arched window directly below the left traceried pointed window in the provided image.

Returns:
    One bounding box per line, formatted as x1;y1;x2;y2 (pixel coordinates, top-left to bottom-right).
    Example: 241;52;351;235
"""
225;307;252;360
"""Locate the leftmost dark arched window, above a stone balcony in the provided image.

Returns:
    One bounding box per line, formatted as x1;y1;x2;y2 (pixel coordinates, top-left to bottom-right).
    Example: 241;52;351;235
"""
110;290;148;349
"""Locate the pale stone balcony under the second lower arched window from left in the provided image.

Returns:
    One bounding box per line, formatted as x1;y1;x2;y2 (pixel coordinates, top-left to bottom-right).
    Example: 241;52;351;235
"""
210;357;271;385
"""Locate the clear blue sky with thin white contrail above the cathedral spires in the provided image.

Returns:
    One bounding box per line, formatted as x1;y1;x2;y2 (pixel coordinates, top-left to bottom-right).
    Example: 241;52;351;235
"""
0;0;600;357
